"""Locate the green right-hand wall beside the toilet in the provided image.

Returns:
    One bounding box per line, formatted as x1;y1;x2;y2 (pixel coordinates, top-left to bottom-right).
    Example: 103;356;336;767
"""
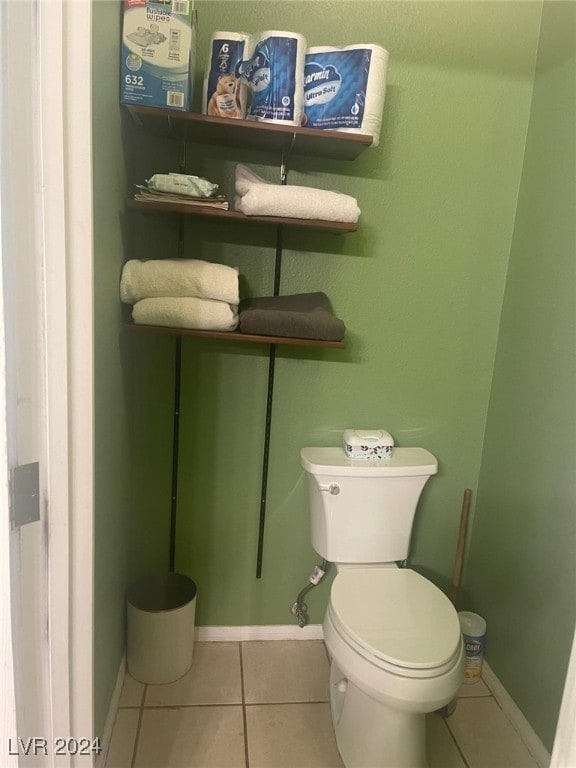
466;2;576;749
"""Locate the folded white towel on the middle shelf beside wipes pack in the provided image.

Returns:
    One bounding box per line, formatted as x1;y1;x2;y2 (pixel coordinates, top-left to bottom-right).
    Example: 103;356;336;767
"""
235;165;360;223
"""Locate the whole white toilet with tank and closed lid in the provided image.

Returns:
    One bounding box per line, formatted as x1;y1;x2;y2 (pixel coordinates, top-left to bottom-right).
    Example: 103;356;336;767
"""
300;448;465;768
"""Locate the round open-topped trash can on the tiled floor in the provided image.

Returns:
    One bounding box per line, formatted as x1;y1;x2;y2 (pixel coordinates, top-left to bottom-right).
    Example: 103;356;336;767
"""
126;573;196;685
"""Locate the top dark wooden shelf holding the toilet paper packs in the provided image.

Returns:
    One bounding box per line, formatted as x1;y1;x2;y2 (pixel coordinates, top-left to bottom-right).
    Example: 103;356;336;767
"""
124;104;372;160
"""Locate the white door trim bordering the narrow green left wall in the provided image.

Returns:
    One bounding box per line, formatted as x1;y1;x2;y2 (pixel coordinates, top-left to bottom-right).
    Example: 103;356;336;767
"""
39;0;94;766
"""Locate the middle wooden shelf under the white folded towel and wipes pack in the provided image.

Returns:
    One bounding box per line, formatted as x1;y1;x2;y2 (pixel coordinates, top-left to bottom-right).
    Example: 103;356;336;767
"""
126;198;358;233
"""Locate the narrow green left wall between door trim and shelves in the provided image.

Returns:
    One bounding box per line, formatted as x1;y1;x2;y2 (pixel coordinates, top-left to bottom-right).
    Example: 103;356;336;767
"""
92;0;132;735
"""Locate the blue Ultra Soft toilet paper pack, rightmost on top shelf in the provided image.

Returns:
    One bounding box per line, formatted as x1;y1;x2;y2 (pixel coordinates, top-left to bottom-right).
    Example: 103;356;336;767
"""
304;43;390;146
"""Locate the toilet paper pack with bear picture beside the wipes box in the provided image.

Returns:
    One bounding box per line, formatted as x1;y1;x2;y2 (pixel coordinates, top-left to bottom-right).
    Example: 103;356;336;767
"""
202;32;252;119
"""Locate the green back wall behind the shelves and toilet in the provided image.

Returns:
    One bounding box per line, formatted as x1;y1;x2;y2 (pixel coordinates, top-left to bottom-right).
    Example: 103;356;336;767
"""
124;1;541;625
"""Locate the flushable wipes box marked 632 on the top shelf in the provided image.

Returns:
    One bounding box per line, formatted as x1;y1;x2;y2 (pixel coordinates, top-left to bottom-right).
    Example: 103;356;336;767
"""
120;0;196;110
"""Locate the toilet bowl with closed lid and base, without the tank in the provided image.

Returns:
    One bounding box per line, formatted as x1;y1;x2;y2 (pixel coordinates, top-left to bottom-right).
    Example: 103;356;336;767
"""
323;567;465;768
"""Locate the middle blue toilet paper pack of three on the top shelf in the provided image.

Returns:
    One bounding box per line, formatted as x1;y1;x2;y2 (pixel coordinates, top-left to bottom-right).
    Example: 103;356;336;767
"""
240;30;306;125
